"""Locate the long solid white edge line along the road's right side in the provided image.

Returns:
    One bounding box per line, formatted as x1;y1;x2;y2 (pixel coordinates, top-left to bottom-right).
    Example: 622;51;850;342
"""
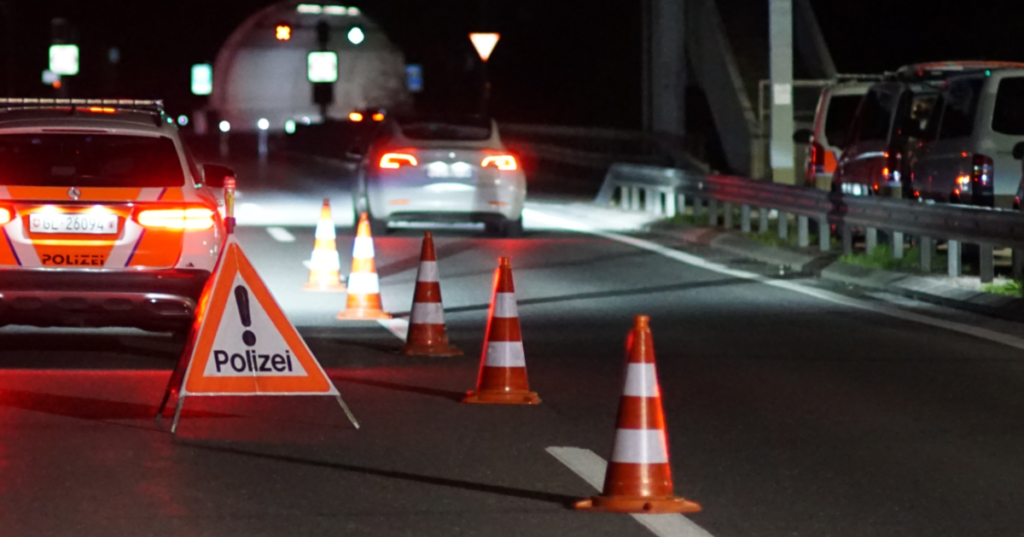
524;209;1024;350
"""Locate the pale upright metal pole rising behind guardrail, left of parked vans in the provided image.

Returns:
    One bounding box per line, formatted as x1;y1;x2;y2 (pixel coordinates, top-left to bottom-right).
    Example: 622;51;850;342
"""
768;0;797;184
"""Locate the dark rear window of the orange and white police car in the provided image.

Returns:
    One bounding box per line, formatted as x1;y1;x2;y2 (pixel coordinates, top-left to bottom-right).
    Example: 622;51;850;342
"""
0;132;185;188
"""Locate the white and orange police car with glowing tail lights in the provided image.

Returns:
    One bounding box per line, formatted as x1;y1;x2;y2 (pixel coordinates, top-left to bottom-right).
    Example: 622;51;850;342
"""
0;98;233;331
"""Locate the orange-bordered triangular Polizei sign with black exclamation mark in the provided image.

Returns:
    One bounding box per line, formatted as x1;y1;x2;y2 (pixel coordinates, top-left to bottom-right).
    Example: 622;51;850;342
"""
181;235;338;397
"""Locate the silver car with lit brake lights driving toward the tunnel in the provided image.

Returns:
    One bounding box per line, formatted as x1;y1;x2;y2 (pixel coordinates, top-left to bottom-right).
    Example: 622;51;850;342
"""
354;116;526;237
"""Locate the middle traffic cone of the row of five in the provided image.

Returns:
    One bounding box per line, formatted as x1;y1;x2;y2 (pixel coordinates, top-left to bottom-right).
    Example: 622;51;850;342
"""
401;232;462;357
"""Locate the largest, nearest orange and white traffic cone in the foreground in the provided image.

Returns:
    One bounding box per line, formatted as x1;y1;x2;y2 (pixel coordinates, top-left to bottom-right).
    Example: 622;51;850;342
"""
575;316;700;513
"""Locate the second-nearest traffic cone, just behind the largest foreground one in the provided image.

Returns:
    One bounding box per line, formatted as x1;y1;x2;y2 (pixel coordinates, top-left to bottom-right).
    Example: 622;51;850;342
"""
462;257;541;405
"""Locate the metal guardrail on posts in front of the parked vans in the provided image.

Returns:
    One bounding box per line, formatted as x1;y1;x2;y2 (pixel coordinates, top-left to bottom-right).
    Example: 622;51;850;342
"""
595;164;1024;282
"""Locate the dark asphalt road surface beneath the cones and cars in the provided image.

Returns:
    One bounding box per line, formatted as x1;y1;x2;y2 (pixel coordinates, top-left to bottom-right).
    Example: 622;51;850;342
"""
0;152;1024;537
